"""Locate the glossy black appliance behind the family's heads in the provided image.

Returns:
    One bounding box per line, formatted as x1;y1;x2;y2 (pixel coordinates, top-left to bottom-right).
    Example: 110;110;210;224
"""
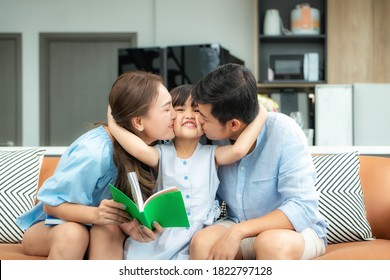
118;43;244;90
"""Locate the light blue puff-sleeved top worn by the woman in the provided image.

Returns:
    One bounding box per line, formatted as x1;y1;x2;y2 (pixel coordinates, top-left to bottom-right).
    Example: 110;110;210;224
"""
16;126;118;230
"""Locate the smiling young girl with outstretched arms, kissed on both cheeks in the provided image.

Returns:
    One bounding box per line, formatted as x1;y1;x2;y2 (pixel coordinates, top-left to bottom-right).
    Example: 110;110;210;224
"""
108;85;267;259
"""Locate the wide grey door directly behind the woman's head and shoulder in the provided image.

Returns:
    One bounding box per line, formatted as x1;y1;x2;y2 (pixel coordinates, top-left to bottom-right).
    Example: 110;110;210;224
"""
40;33;137;146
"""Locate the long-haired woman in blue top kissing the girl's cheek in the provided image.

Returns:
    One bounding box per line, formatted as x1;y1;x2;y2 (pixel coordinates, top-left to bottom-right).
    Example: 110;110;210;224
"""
17;72;176;259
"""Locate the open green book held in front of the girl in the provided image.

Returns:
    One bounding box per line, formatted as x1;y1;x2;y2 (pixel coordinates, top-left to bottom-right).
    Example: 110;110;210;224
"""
109;184;190;229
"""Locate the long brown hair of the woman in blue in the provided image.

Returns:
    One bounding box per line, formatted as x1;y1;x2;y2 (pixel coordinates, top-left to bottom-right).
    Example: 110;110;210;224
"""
109;71;163;198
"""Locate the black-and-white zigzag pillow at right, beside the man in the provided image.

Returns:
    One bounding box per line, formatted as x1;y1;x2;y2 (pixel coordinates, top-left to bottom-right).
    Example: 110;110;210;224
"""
313;152;373;244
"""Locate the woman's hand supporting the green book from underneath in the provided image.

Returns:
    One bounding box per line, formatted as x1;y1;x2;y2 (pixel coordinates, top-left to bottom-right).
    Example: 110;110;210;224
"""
119;220;163;243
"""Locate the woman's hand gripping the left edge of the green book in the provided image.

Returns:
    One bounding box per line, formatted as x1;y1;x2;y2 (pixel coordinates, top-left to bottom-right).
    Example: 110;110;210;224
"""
94;199;130;225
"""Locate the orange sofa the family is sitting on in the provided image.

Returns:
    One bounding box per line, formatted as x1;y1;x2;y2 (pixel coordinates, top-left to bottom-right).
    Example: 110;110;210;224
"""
0;156;390;260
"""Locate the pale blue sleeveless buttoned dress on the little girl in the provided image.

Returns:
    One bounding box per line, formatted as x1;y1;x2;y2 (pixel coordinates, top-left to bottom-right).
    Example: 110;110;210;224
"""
124;142;220;260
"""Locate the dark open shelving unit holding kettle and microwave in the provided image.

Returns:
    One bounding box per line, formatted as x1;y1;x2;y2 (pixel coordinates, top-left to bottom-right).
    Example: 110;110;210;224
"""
257;0;327;137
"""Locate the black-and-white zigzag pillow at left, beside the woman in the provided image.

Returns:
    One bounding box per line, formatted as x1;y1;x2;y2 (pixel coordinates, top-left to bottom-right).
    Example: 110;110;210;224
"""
0;148;45;243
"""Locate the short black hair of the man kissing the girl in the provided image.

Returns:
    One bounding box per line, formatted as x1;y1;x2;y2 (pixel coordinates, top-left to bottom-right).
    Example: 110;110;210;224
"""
192;63;259;125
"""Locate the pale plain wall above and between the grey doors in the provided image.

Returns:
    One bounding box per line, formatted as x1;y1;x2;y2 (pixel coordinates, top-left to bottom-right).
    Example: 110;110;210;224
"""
0;0;257;146
